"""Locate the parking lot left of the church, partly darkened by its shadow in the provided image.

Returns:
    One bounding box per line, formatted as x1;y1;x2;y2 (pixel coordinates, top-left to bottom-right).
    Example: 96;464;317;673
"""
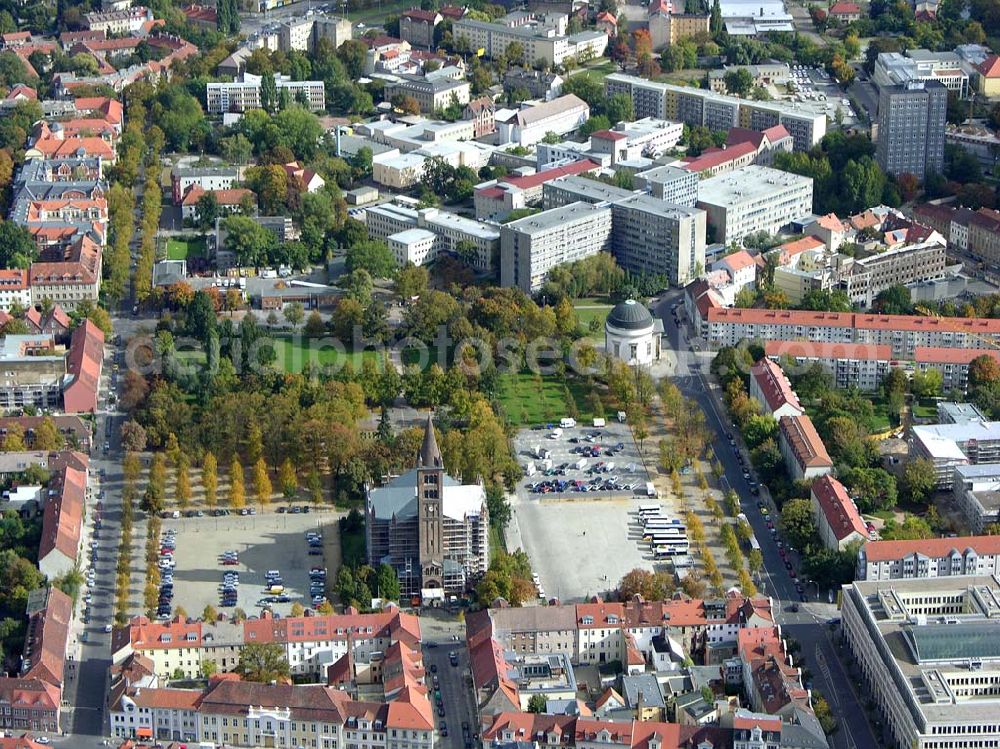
163;512;339;617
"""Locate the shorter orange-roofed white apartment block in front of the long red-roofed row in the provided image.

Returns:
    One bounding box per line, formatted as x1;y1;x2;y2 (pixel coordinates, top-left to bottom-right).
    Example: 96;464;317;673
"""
764;340;893;393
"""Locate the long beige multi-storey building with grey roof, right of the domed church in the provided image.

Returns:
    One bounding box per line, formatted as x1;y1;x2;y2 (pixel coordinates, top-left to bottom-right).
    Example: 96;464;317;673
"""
840;236;947;307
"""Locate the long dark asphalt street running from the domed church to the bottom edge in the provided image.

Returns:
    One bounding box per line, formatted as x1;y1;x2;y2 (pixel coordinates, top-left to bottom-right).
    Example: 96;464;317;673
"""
654;291;881;749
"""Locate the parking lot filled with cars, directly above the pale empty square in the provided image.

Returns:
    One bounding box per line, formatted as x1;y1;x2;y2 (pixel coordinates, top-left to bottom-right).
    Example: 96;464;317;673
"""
514;421;649;500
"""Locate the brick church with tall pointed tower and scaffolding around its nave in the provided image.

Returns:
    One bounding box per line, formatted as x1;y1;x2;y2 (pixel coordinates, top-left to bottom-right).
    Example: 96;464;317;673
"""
365;414;490;598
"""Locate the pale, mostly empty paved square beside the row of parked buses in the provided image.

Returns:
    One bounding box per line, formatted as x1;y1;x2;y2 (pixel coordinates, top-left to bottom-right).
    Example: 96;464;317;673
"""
508;495;677;602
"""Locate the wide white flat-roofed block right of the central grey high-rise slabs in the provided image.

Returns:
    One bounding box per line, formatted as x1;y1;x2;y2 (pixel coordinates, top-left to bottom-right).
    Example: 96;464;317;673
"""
698;166;813;244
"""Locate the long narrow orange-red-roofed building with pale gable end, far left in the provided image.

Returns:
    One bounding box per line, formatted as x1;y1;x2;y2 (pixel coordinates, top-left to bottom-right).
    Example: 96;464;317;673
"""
38;467;87;580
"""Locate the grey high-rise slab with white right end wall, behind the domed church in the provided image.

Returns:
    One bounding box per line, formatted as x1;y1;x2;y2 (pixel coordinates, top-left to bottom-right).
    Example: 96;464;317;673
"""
611;195;705;286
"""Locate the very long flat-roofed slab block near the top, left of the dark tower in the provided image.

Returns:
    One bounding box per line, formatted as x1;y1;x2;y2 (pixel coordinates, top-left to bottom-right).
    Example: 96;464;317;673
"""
604;73;826;151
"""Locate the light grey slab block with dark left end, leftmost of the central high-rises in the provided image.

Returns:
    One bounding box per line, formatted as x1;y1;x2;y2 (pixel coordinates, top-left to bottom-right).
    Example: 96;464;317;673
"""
500;202;612;294
